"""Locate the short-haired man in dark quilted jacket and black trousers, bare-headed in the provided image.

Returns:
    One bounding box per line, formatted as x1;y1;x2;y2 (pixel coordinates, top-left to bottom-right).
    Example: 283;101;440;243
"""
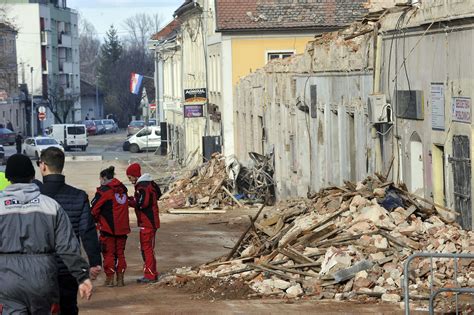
37;147;102;314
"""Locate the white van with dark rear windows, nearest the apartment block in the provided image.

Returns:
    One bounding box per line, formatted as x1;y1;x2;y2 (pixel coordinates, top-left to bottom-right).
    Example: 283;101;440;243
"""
48;124;89;151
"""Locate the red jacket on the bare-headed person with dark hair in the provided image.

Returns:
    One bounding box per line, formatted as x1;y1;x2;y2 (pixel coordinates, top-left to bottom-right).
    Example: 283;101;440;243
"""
92;178;130;236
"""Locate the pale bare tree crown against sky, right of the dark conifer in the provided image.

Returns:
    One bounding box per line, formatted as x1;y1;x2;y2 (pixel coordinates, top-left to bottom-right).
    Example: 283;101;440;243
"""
123;13;162;48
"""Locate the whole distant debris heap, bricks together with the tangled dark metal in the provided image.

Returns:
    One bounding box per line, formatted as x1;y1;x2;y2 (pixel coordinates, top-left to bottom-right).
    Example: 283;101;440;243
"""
160;152;275;211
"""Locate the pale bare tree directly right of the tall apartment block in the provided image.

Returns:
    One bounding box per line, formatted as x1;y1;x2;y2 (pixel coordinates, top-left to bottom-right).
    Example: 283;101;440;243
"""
79;16;100;83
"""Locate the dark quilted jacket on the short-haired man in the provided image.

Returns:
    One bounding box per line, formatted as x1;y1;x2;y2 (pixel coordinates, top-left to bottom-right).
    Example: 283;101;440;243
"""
39;174;102;275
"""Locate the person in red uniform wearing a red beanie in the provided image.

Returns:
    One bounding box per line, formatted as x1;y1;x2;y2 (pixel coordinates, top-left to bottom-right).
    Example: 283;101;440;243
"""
127;163;161;283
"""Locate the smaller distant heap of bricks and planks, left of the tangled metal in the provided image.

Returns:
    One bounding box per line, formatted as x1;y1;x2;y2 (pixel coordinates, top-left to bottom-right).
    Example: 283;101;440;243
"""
160;154;234;210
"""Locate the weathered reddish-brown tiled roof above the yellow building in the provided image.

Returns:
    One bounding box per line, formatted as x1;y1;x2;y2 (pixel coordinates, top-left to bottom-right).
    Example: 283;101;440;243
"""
216;0;368;31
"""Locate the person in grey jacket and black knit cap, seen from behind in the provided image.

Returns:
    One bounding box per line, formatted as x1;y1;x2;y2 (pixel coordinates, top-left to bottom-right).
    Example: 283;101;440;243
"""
0;154;92;314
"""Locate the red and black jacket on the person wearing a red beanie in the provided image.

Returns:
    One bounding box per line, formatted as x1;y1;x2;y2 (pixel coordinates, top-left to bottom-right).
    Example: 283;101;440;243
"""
130;174;161;230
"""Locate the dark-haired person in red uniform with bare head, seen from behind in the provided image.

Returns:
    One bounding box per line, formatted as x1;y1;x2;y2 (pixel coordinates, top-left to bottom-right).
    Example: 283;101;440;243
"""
92;166;130;287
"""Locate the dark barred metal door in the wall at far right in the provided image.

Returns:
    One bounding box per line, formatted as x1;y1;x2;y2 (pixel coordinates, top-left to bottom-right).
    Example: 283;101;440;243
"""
450;136;472;230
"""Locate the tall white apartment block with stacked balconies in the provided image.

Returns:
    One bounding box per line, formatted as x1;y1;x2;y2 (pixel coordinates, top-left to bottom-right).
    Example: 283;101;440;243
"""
6;0;81;135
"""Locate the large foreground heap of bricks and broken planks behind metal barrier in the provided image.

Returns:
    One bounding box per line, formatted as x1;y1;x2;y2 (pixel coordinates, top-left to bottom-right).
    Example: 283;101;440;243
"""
165;177;474;310
